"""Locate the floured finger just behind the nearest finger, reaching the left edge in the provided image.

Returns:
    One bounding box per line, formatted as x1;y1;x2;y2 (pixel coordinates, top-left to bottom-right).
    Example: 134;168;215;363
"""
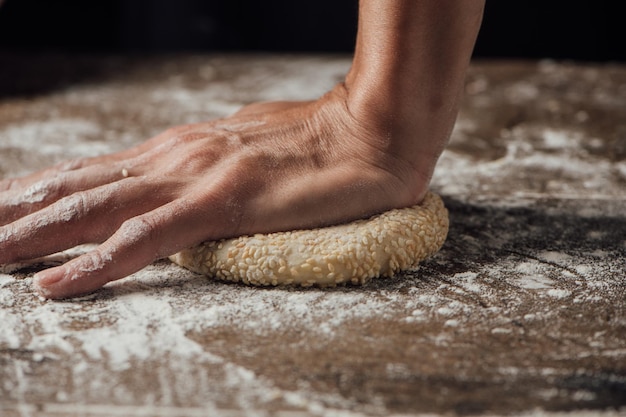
0;177;171;264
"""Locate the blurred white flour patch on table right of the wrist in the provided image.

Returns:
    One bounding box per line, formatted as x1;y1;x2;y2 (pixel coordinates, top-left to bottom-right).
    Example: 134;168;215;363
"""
432;125;623;199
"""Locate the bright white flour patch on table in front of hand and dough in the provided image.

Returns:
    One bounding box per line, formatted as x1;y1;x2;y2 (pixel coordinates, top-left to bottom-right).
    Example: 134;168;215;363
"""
0;264;432;407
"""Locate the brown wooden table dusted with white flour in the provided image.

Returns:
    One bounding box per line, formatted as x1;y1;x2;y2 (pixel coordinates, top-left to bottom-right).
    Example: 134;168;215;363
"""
0;54;626;417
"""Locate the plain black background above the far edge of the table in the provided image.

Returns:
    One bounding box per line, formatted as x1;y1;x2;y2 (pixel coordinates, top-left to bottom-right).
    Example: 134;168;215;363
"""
0;0;626;61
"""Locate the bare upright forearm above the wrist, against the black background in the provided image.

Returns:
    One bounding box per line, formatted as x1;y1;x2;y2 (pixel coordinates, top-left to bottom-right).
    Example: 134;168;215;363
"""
346;0;484;170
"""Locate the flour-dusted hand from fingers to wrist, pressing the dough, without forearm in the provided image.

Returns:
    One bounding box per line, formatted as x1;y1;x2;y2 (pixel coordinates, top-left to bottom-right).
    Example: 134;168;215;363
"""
0;85;424;298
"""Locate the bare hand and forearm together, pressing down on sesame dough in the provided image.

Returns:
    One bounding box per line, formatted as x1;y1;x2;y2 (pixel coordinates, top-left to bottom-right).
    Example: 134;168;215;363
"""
0;0;484;299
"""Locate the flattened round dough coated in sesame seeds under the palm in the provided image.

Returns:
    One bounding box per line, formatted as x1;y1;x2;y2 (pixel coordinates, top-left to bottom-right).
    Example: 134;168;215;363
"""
170;192;448;287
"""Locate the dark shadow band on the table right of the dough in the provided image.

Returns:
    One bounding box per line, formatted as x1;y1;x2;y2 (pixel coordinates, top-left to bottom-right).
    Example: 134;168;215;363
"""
433;198;626;275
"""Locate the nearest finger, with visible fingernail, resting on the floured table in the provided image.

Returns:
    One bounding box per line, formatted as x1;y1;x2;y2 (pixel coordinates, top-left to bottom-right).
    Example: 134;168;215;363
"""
33;200;208;299
